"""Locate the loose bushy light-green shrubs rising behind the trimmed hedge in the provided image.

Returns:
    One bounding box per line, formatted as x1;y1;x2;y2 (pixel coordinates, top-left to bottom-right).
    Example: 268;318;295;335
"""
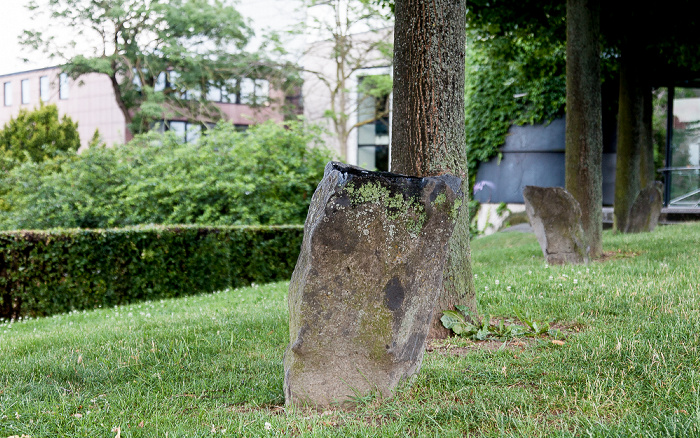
0;122;331;229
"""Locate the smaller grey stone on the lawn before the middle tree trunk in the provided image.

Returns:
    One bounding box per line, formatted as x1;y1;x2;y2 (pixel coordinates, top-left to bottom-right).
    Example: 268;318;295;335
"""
523;186;589;265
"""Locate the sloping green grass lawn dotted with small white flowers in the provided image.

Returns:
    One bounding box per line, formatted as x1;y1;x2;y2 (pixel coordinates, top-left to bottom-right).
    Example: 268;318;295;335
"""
0;224;700;438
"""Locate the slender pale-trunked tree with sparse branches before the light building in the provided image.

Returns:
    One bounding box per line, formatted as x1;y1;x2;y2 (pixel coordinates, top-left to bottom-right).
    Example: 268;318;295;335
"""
299;0;393;159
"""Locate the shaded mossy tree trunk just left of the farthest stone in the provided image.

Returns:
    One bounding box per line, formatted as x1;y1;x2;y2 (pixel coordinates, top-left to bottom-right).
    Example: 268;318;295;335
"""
613;48;644;232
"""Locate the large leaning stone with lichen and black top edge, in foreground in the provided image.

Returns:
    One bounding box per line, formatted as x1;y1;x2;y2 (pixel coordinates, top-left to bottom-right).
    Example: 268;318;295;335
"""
284;162;462;408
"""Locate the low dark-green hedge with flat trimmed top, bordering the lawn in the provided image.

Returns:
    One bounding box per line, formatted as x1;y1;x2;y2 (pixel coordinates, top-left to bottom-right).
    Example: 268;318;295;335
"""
0;226;304;318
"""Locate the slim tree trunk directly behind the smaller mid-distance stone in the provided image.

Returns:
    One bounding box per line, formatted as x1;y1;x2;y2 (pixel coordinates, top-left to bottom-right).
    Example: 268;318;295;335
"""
566;0;603;258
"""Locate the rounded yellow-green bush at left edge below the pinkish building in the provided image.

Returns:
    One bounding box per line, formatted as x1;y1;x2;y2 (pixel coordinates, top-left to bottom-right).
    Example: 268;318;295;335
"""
0;104;80;172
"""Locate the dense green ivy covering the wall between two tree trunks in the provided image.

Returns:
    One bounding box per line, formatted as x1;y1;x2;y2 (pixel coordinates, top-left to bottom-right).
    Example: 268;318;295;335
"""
465;31;566;186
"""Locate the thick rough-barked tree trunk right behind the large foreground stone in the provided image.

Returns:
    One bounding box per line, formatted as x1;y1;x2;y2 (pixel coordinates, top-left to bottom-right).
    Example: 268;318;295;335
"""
391;0;477;338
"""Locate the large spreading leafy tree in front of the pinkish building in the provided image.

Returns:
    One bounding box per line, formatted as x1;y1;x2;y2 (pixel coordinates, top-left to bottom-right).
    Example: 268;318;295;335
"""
21;0;292;133
